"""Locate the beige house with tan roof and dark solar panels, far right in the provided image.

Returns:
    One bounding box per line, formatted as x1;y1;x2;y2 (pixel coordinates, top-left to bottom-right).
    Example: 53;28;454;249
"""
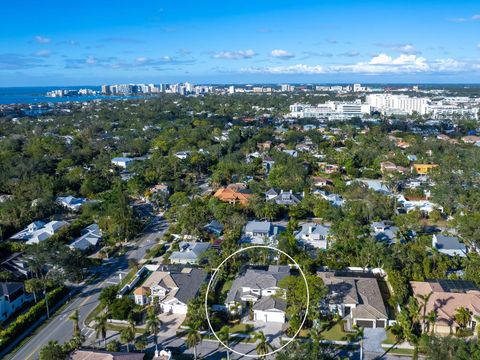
410;280;480;335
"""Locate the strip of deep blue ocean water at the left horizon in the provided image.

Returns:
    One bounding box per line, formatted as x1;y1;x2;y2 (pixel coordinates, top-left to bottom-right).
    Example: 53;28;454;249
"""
0;86;133;104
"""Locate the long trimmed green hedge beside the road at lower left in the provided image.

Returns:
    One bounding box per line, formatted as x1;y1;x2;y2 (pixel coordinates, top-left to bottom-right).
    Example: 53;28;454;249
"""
0;286;68;350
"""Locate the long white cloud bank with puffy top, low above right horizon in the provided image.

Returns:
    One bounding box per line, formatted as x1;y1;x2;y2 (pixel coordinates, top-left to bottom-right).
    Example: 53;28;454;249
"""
241;53;480;75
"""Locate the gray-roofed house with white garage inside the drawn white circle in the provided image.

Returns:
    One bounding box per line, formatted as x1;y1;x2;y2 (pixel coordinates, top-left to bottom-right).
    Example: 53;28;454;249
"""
225;265;290;323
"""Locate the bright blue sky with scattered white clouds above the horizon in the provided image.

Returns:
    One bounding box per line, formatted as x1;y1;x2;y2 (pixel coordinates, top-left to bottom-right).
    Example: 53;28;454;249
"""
0;0;480;86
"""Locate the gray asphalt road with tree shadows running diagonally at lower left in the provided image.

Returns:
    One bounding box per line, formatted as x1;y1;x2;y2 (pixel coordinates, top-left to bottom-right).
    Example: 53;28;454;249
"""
6;216;168;360
